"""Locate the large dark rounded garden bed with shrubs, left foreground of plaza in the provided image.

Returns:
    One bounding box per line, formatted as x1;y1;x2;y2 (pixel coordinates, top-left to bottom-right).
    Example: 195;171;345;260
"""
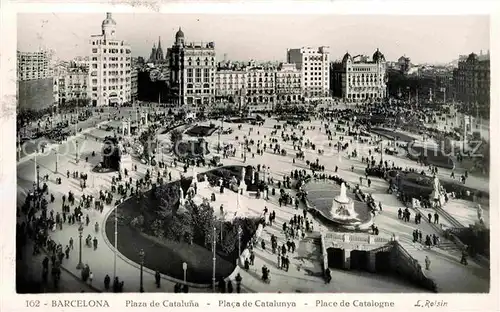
105;173;259;285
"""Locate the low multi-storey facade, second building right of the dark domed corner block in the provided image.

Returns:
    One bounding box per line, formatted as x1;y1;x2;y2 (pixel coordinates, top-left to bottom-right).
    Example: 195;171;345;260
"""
245;64;276;112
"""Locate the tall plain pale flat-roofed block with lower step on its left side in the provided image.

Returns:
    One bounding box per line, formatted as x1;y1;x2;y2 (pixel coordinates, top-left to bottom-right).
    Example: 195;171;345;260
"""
287;47;330;100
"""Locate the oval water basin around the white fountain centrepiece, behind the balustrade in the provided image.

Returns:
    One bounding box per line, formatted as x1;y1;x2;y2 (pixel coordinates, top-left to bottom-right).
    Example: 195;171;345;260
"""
303;181;373;231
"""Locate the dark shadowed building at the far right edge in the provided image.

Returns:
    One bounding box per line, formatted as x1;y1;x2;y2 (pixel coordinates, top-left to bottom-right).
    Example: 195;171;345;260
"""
453;51;490;116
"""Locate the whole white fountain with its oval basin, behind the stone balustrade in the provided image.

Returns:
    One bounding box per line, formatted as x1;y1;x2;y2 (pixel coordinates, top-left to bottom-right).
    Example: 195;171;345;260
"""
303;182;373;231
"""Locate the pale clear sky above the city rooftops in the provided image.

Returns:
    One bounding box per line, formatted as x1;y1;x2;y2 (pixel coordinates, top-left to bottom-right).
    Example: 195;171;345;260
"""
17;13;490;64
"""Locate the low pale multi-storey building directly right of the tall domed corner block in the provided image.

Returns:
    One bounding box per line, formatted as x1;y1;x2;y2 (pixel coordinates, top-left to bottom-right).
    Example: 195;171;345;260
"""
214;64;247;109
